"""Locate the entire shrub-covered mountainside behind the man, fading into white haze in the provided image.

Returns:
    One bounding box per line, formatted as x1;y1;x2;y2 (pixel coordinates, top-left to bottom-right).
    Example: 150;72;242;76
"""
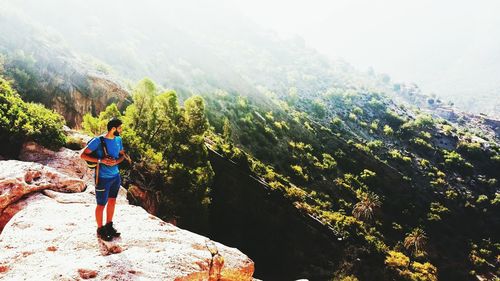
0;1;500;280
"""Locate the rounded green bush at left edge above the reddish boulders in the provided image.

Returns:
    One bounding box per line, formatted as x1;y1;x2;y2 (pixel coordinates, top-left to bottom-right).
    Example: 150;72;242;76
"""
0;76;66;157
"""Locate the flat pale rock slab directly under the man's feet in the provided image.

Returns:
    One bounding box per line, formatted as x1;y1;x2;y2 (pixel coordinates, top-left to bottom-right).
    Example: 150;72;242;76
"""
0;194;253;280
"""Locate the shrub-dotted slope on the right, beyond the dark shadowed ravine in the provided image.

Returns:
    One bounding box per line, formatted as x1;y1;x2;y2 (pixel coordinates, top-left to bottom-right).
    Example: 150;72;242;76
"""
200;86;500;280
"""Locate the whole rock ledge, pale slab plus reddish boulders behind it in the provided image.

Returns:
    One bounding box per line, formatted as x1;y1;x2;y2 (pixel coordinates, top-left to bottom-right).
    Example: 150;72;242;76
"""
0;143;254;280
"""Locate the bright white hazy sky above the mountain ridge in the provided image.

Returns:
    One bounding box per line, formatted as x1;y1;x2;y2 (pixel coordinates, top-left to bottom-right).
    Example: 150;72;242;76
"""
0;0;500;110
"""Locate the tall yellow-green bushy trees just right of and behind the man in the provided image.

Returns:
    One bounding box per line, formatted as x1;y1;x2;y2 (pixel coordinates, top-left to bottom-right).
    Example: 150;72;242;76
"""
83;79;213;232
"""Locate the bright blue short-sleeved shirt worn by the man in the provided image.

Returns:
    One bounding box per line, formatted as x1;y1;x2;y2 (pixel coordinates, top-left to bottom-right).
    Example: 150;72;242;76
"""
87;137;123;178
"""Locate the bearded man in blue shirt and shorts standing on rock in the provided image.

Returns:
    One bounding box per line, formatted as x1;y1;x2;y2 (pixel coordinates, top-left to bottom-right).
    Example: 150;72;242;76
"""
80;118;125;241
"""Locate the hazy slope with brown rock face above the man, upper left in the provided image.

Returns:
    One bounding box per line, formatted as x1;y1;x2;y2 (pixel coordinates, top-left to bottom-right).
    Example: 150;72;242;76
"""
0;11;129;128
